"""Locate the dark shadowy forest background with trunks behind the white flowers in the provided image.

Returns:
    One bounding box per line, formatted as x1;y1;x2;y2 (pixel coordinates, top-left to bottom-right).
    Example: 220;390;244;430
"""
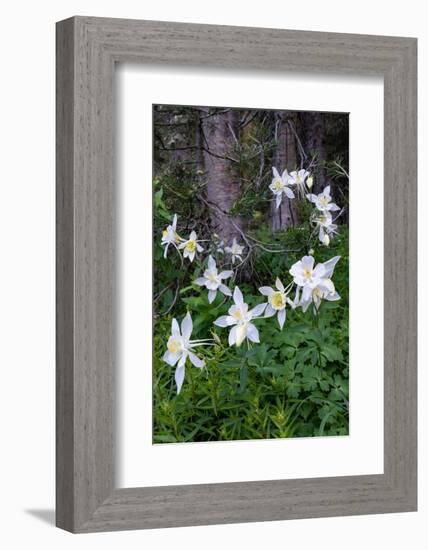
153;105;349;246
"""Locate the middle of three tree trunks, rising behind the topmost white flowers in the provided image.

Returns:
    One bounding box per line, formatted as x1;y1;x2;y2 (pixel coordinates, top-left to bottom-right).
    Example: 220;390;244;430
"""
271;112;298;231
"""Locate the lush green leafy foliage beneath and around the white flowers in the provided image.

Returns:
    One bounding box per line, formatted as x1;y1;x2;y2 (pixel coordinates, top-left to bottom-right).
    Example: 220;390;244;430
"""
153;213;349;443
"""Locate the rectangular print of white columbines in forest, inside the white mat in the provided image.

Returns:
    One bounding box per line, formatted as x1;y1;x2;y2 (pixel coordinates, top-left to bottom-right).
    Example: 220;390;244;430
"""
153;105;349;444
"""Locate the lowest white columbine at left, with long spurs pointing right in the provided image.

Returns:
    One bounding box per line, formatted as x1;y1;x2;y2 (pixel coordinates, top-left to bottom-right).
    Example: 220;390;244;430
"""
163;313;209;394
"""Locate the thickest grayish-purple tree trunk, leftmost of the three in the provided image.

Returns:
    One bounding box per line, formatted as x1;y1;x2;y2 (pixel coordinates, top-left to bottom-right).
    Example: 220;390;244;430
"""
201;109;242;244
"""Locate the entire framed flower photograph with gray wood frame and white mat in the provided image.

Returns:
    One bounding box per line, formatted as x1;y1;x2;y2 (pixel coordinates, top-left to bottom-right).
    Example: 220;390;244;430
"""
57;17;417;533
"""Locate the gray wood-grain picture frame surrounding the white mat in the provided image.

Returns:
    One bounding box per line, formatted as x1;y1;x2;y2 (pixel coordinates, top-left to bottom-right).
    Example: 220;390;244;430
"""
56;17;417;533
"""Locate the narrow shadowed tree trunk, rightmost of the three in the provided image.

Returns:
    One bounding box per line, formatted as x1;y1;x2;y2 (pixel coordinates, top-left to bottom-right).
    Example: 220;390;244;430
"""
301;111;328;194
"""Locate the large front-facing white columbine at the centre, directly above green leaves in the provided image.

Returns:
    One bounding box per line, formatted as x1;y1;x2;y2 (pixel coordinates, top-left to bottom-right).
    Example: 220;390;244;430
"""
214;286;266;347
